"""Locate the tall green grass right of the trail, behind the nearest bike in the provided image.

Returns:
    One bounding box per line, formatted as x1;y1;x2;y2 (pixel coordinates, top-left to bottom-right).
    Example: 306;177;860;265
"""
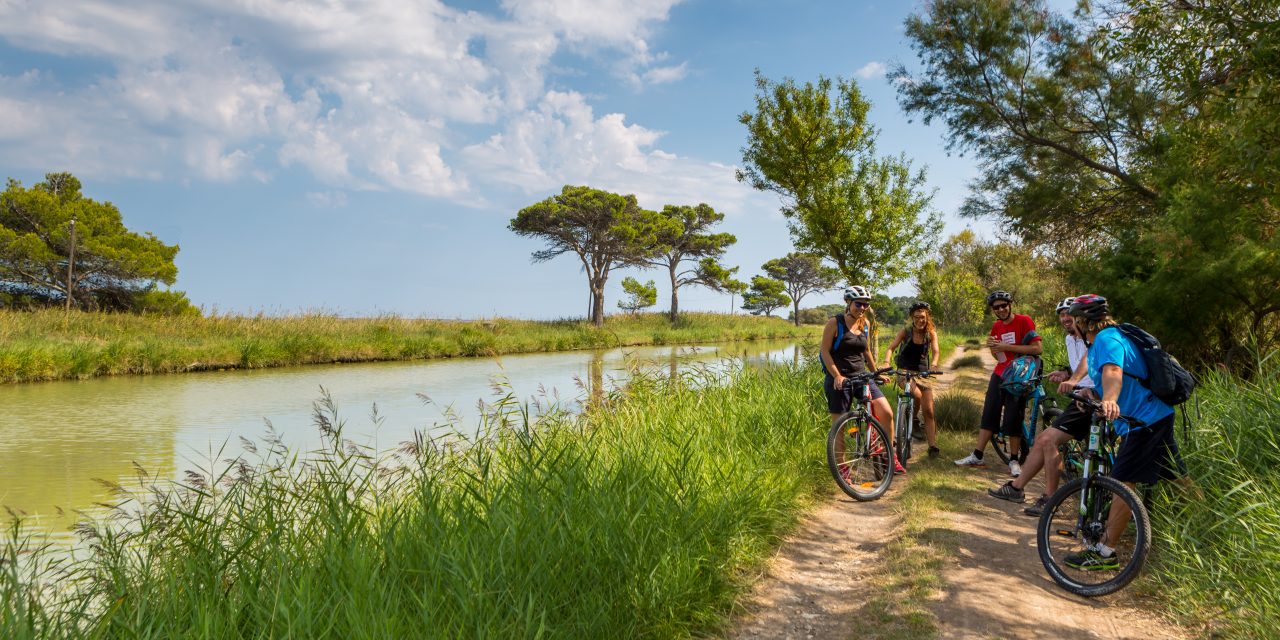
1151;352;1280;639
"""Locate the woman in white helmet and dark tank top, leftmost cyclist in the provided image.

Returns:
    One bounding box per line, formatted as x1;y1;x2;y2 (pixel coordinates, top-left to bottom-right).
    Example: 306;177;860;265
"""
819;287;906;474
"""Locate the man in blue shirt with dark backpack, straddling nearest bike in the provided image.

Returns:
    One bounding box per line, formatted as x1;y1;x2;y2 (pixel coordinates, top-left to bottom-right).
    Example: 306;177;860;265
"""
1066;293;1185;570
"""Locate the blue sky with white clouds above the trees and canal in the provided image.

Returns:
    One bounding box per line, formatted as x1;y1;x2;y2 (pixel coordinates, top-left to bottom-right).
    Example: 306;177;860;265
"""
0;0;992;319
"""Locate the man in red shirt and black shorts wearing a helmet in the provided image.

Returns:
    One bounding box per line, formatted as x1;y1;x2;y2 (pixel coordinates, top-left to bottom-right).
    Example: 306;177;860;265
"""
956;291;1044;477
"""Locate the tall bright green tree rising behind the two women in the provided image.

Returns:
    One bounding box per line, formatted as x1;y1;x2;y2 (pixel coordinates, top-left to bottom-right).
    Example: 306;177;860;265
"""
737;70;941;287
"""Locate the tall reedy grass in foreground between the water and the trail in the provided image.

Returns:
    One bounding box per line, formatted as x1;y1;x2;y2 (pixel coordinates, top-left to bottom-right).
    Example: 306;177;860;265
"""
0;366;831;639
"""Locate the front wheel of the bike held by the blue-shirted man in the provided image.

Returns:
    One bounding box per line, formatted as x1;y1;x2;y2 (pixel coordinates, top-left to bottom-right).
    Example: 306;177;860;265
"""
1036;476;1151;598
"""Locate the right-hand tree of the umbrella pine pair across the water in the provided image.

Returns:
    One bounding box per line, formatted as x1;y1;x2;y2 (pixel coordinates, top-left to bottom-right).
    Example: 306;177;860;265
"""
644;204;737;323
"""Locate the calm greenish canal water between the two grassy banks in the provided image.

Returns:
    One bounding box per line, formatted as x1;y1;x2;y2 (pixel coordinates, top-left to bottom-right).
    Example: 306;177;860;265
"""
0;340;801;538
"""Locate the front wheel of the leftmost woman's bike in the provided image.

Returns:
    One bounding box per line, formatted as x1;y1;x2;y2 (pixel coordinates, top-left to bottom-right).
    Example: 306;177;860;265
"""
827;413;893;502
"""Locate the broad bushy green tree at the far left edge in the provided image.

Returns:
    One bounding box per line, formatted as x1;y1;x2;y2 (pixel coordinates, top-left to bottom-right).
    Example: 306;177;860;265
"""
0;173;178;310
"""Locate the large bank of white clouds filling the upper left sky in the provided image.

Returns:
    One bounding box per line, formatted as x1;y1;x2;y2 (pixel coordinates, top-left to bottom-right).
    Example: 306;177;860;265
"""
0;0;690;202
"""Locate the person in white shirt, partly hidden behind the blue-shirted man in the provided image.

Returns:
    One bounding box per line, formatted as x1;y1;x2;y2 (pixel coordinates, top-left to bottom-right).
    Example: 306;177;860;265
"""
987;293;1097;516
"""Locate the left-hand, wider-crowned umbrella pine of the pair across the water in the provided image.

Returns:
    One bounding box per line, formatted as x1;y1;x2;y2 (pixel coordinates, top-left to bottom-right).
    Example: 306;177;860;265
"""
507;186;655;326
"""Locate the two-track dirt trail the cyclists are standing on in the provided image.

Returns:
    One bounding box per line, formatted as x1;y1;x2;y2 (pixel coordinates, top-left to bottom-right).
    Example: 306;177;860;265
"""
728;349;1189;640
